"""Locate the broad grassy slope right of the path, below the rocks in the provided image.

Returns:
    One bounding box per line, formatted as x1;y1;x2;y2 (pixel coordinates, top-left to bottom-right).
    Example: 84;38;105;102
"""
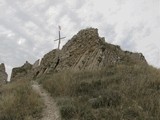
39;65;160;120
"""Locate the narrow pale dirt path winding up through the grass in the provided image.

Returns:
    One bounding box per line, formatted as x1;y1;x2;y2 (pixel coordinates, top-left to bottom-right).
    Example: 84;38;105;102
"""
32;82;61;120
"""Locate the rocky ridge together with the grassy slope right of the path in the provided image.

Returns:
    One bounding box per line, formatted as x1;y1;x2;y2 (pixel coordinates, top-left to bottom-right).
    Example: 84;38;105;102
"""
7;28;160;120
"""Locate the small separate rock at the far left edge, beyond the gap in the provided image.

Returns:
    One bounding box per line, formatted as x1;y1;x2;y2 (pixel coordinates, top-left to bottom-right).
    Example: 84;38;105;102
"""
0;63;8;85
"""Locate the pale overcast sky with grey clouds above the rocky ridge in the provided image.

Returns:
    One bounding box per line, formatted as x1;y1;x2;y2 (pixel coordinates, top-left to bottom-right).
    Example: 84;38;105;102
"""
0;0;160;79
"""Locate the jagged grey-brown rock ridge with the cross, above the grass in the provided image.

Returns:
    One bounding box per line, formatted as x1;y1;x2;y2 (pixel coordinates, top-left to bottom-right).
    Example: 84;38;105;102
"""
11;28;147;80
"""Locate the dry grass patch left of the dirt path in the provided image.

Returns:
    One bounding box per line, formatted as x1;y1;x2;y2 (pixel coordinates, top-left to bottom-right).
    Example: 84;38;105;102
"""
0;80;43;120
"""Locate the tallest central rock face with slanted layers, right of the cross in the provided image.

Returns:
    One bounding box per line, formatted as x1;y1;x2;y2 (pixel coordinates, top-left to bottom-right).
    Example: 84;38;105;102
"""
57;28;104;71
